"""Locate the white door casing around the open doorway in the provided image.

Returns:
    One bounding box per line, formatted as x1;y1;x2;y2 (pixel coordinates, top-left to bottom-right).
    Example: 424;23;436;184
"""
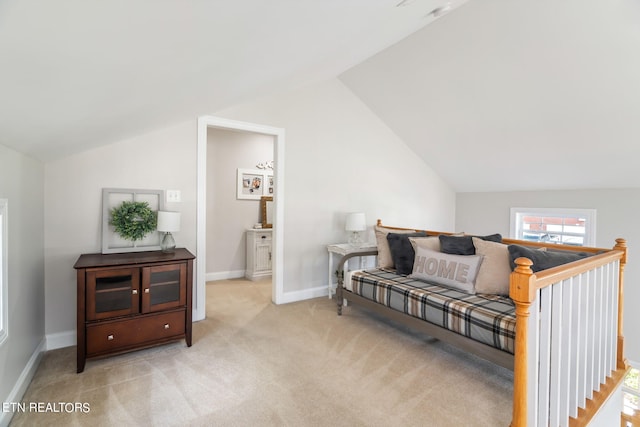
193;116;284;321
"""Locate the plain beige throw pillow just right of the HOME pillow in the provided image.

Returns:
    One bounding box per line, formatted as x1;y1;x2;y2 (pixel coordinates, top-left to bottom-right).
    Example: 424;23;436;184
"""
473;237;512;296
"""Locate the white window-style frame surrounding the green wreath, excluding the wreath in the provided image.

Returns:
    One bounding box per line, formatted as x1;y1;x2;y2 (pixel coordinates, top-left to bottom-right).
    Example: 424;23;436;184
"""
102;188;164;254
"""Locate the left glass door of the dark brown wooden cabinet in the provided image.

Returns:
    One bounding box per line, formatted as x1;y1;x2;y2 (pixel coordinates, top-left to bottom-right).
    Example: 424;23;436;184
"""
86;268;140;320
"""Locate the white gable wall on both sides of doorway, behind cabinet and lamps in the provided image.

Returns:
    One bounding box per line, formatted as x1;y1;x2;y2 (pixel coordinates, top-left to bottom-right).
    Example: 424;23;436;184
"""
45;80;455;338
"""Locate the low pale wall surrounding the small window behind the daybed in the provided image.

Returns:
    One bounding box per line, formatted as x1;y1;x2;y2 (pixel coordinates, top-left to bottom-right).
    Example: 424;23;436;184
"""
456;189;640;362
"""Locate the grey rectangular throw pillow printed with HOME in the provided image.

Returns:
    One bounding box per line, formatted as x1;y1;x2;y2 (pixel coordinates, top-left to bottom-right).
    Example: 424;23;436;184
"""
409;247;482;294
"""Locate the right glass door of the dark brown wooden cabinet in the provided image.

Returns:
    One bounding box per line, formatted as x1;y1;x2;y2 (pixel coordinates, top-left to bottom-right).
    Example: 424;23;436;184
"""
142;263;187;313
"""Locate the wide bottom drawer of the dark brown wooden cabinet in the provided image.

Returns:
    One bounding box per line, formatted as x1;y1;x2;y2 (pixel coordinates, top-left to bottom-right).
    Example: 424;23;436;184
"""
87;310;185;356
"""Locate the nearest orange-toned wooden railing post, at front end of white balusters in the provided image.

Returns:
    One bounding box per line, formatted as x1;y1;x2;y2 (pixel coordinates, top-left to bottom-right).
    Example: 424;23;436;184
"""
509;258;537;427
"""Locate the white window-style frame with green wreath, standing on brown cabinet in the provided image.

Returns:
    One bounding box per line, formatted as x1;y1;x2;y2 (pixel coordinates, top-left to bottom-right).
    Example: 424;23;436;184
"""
102;188;164;254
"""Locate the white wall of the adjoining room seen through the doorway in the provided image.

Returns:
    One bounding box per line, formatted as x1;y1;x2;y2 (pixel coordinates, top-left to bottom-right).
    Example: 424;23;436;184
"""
206;128;274;279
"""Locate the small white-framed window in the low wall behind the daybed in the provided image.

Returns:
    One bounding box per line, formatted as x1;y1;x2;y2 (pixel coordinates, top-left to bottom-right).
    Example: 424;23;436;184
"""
511;208;596;246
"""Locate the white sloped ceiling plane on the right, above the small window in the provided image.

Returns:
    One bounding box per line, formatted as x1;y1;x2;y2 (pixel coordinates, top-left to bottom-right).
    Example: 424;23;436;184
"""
341;0;640;192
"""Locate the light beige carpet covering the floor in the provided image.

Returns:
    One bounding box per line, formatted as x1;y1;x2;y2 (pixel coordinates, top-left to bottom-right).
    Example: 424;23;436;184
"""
11;280;513;427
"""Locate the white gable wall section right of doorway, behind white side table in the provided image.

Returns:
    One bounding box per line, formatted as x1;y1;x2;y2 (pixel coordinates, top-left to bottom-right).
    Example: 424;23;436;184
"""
216;79;455;292
